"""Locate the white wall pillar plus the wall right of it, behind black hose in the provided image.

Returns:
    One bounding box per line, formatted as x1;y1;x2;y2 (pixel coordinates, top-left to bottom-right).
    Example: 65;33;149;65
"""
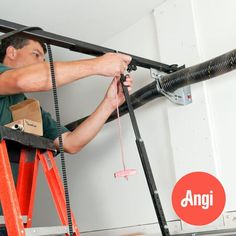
155;0;236;229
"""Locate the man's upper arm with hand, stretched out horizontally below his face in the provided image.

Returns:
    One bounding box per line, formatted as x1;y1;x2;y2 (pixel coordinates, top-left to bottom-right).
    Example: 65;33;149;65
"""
0;53;131;95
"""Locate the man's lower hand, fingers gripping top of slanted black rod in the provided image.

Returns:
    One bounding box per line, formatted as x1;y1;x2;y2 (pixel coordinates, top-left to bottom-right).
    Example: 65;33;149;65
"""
105;75;133;110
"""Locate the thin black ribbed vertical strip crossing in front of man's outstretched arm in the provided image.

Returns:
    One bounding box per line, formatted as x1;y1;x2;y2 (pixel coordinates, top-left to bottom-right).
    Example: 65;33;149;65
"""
47;44;73;236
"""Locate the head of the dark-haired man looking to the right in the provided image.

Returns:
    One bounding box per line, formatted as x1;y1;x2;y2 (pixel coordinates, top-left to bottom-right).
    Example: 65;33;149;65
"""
0;35;47;68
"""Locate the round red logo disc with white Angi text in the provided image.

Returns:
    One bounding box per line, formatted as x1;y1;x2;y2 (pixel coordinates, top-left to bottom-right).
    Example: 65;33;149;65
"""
172;172;225;225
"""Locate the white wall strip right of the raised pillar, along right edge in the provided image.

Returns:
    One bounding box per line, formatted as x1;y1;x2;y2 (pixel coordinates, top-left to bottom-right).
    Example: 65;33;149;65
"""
193;0;236;211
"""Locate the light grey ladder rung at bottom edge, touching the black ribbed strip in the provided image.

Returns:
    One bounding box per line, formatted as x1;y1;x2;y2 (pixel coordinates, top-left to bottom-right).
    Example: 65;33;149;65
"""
25;226;69;236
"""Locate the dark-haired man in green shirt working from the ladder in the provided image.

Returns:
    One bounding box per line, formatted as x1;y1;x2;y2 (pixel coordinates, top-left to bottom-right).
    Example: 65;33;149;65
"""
0;36;132;235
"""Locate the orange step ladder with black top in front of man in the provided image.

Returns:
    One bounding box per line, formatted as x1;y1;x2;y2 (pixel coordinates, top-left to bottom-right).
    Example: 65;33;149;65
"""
0;126;80;236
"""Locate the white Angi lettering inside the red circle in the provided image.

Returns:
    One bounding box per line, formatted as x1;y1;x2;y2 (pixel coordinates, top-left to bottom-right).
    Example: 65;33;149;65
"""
180;190;213;210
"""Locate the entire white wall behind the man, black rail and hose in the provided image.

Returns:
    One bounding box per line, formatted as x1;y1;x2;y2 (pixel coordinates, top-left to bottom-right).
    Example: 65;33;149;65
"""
31;0;236;235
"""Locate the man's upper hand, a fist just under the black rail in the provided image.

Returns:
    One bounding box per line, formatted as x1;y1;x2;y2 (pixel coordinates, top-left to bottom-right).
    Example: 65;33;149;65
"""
94;53;132;77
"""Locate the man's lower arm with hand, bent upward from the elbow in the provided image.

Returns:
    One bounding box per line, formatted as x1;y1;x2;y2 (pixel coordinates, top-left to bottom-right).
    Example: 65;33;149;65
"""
54;77;133;154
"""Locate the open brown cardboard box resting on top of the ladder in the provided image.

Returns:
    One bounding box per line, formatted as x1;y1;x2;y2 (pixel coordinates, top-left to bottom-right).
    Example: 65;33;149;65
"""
6;99;43;136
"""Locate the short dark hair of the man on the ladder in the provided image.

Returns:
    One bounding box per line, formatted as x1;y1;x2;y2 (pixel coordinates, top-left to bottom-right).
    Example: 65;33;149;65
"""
0;35;47;63
